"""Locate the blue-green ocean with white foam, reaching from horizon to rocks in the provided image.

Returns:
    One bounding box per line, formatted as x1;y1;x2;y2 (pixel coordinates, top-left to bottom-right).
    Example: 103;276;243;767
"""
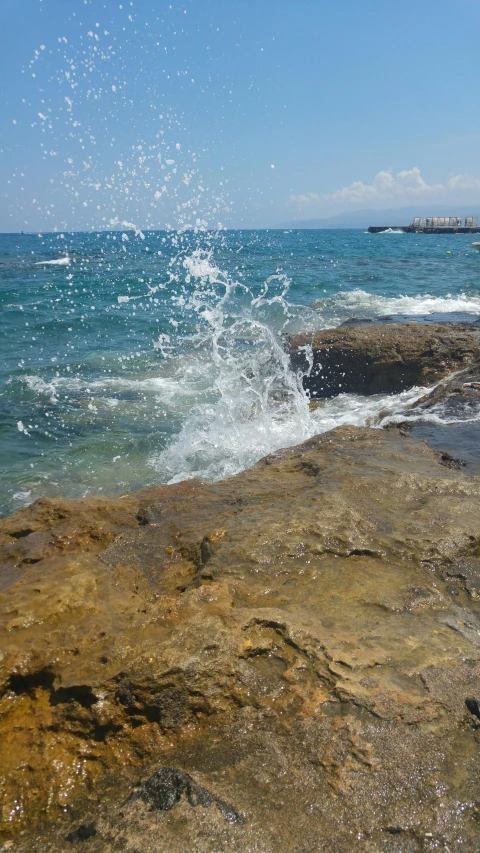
0;229;480;514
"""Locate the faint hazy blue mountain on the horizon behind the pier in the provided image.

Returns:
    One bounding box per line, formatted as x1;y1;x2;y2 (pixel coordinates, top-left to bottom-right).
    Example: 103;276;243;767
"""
272;204;480;229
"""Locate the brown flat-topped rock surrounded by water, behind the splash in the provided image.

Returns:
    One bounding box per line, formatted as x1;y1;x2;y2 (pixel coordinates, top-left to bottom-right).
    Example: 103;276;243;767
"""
288;323;480;398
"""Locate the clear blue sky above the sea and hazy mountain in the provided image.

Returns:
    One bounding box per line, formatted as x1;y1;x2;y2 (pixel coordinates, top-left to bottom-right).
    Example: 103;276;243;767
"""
0;0;480;232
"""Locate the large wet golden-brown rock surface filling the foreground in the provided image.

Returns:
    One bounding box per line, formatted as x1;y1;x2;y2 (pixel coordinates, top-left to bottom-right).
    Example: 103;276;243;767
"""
0;427;480;853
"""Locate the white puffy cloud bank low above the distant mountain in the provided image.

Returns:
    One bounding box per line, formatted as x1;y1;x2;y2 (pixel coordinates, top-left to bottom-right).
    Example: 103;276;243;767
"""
288;166;480;210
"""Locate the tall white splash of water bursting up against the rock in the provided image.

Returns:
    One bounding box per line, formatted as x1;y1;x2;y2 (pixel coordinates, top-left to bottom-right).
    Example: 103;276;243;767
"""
151;250;311;482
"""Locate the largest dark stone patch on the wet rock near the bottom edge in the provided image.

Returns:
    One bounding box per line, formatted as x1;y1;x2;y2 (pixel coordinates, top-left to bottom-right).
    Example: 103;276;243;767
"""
127;767;243;823
